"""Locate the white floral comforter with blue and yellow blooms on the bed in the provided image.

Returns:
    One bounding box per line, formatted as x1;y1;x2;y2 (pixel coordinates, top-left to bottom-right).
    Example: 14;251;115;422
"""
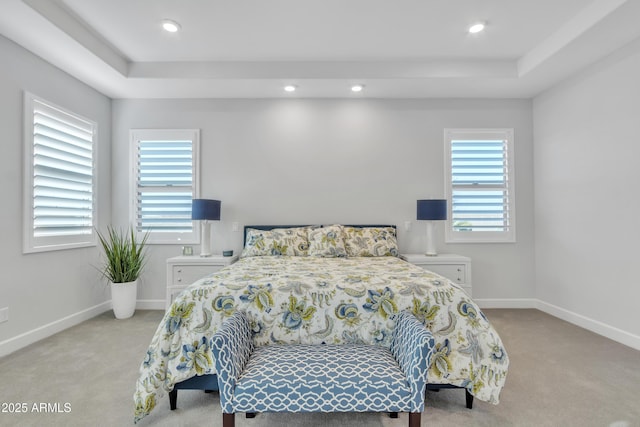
134;256;509;421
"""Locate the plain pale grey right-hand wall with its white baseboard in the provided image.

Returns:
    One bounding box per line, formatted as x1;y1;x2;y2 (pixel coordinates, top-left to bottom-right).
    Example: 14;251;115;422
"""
533;36;640;348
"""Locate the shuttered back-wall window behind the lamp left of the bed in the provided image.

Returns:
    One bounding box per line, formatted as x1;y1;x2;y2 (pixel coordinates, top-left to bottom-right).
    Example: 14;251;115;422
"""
131;129;200;243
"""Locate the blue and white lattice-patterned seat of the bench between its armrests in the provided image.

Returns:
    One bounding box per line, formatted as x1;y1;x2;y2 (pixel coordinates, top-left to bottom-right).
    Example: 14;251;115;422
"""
233;344;410;412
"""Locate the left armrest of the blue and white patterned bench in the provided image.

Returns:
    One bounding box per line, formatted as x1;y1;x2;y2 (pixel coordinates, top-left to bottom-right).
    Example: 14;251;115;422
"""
211;311;253;413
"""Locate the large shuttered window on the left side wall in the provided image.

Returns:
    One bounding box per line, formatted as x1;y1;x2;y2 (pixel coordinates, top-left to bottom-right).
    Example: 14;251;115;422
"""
23;92;97;253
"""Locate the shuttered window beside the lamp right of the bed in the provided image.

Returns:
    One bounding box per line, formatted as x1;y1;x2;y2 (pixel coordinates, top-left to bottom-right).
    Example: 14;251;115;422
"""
445;129;515;243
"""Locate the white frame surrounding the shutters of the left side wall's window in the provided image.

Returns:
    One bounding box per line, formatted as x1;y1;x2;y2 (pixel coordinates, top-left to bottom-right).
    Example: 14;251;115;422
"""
22;91;98;254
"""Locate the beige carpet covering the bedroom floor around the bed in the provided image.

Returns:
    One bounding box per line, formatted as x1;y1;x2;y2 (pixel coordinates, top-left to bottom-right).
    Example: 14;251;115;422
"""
0;310;640;427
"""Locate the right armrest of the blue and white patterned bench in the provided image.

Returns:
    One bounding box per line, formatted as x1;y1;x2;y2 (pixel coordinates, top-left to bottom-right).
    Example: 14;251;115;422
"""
390;311;435;412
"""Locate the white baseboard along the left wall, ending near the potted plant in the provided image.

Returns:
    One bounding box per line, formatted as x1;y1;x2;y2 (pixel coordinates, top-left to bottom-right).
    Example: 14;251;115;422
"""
0;301;111;357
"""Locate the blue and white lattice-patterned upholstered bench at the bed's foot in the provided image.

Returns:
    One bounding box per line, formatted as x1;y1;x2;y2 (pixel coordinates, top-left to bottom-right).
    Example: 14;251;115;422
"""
211;312;434;427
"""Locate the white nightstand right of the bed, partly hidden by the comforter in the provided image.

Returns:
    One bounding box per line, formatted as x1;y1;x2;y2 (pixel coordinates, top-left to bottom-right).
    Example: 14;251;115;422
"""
400;254;472;297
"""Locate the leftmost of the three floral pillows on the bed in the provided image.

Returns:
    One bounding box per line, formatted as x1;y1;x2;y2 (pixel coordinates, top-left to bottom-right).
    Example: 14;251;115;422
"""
240;227;309;258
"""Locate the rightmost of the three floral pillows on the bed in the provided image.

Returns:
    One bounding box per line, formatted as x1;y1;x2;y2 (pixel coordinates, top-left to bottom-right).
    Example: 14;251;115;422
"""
343;227;398;257
